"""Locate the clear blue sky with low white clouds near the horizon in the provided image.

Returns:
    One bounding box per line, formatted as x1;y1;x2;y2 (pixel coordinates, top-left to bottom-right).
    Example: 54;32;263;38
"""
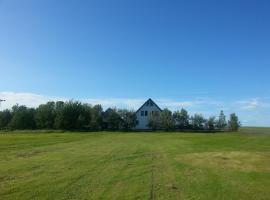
0;0;270;126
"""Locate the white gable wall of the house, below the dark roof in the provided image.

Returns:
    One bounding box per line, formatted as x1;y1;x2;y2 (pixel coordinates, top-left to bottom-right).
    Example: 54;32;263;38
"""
136;104;160;129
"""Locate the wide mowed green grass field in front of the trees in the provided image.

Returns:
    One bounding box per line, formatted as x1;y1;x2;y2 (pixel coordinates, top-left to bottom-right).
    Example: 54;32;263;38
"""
0;129;270;200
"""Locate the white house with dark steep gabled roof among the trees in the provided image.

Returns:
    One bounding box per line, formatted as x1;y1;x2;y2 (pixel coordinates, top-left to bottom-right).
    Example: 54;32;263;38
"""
135;99;162;130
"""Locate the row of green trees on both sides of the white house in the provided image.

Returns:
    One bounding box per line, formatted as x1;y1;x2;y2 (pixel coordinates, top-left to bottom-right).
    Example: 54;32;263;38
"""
0;101;240;131
